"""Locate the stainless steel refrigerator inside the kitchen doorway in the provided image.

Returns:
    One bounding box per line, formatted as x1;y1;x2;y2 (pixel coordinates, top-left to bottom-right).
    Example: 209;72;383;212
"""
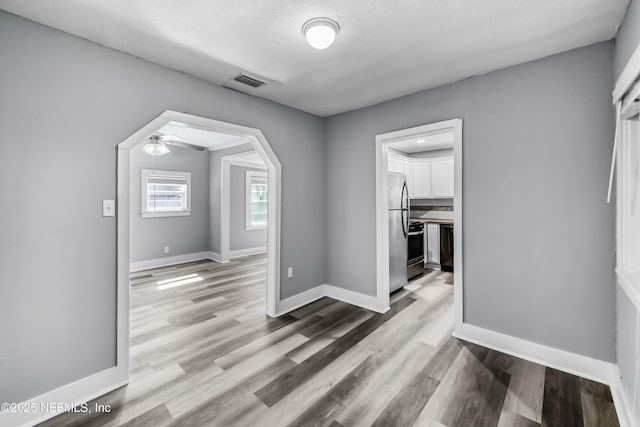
389;173;409;292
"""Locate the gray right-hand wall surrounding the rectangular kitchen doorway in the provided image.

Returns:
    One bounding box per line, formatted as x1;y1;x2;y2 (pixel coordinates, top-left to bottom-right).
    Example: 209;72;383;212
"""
325;42;615;362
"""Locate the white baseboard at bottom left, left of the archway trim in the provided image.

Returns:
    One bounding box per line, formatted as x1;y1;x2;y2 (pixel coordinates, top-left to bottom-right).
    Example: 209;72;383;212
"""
0;367;128;427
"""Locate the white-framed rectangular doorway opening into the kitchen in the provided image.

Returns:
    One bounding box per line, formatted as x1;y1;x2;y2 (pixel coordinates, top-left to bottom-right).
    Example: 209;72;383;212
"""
376;119;463;329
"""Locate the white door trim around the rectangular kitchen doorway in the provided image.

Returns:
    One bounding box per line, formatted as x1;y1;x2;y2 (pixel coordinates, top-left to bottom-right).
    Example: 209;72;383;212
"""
376;119;463;329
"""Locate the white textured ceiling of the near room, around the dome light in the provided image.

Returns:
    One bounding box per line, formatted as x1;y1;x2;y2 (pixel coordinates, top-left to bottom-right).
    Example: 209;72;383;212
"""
0;0;629;116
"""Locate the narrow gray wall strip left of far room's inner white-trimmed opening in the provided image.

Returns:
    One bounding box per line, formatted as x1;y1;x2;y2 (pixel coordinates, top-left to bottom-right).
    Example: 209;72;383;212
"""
209;144;253;254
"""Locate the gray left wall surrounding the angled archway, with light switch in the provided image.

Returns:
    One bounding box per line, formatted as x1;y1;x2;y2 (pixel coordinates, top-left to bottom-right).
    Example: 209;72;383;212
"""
0;12;325;402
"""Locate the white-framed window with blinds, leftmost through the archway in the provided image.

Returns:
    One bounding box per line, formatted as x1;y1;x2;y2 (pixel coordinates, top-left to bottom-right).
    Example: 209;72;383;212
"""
140;169;191;218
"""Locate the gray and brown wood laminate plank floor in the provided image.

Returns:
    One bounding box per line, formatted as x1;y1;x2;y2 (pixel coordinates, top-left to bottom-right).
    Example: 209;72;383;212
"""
42;256;618;427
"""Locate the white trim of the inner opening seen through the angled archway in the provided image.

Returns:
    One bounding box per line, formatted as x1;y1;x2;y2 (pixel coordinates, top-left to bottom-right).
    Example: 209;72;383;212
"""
220;152;271;262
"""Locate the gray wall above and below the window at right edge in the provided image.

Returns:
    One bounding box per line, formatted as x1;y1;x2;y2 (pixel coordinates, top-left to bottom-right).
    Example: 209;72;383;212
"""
614;0;640;421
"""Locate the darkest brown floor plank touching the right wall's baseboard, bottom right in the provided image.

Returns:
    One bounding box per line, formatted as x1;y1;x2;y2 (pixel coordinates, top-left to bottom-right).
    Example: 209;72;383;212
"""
542;368;584;427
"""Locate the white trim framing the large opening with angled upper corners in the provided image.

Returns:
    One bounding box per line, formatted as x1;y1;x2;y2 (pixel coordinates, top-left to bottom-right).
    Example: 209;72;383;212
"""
116;110;281;388
